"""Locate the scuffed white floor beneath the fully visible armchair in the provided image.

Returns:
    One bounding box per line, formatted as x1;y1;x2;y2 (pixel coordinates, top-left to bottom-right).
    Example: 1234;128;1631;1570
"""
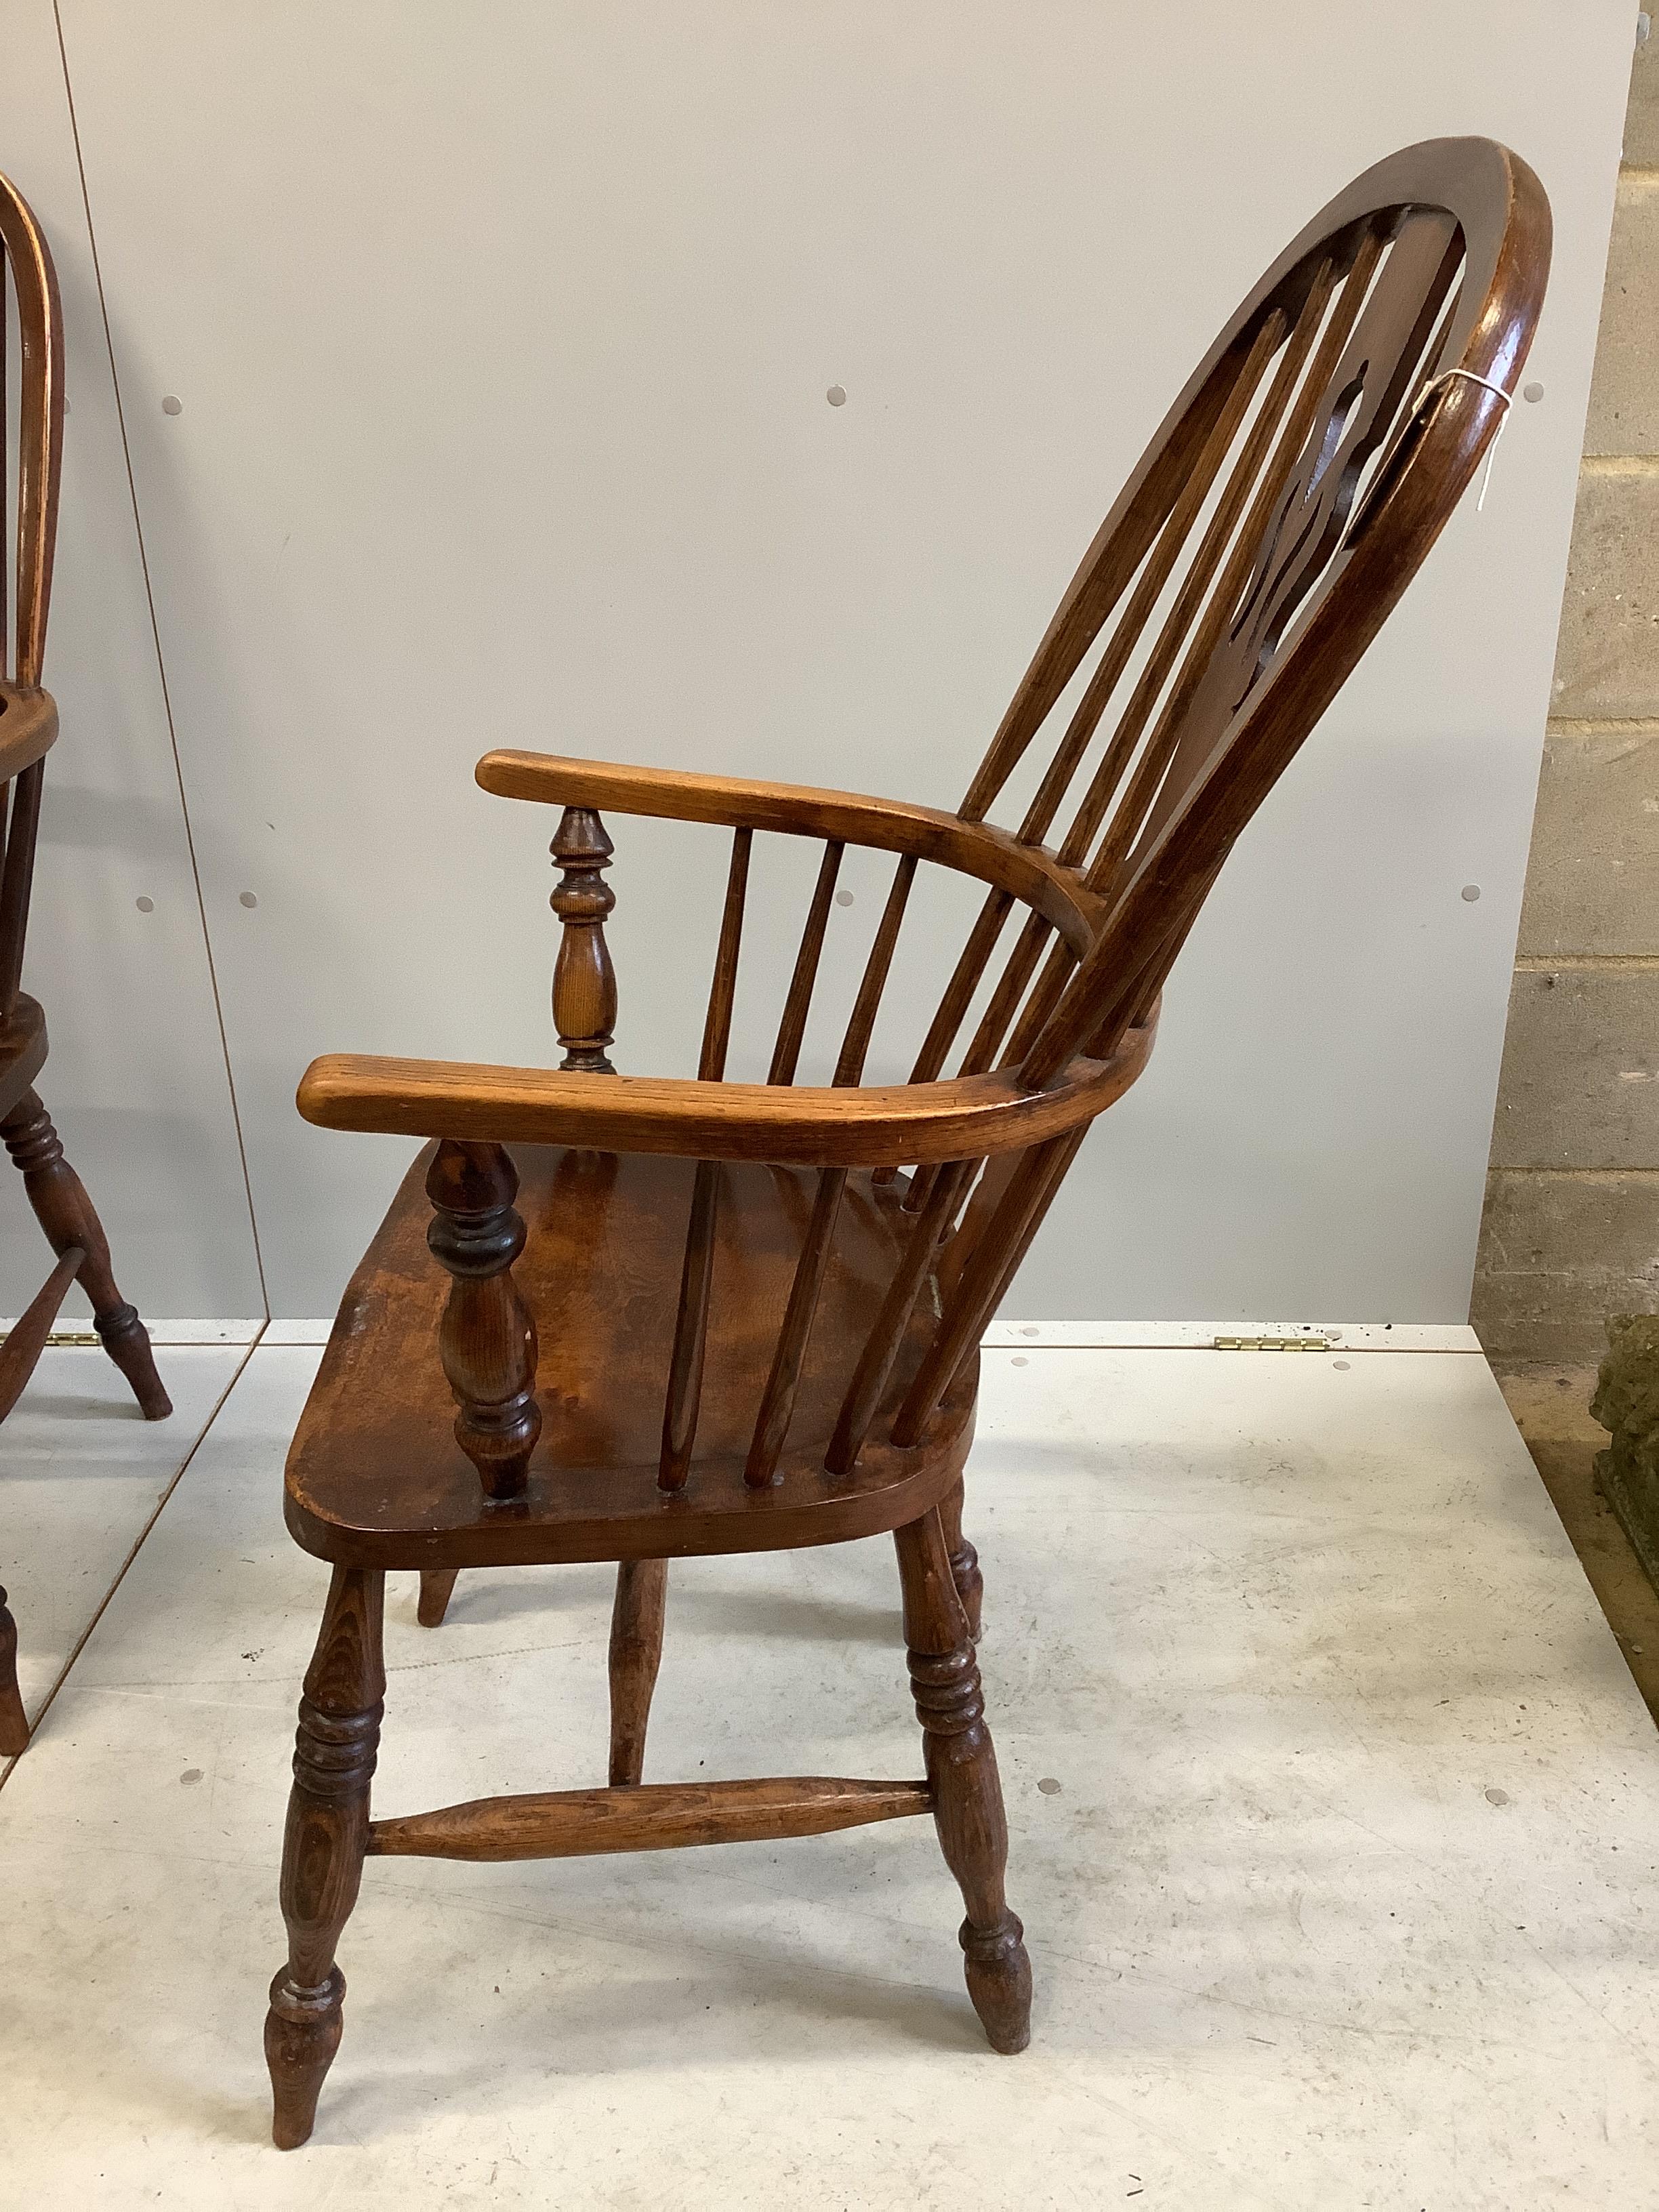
0;1343;1659;2212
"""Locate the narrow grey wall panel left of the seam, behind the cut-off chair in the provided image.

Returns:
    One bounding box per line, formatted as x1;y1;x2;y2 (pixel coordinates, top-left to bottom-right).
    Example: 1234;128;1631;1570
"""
0;0;263;1316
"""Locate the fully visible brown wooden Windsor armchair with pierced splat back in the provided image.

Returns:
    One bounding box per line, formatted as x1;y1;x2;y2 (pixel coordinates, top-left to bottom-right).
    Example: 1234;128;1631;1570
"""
266;140;1549;2146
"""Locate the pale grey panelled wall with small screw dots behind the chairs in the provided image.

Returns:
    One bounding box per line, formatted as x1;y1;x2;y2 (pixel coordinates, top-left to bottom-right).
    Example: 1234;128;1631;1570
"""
0;0;1633;1321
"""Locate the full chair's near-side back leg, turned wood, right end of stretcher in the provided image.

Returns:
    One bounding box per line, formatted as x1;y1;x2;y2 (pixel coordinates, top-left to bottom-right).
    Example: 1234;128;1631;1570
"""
894;1507;1031;2053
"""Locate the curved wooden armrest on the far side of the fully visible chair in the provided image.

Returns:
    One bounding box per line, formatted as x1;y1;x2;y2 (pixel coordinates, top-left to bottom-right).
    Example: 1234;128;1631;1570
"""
473;752;1101;954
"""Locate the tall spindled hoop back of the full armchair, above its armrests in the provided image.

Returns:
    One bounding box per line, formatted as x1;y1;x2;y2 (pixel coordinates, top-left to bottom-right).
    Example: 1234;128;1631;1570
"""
960;140;1551;1086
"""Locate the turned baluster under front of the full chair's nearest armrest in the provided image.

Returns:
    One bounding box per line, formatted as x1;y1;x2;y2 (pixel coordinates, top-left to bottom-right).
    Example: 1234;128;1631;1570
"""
427;1139;542;1498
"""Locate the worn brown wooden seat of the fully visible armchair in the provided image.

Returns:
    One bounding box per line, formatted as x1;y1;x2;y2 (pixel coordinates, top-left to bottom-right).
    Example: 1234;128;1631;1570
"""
285;1143;978;1568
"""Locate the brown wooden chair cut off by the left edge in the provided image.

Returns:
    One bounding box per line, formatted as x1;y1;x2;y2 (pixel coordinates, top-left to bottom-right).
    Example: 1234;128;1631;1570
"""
0;177;173;1752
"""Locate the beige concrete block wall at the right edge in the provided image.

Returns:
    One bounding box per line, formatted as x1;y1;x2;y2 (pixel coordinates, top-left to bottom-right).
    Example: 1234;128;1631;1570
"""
1471;21;1659;1363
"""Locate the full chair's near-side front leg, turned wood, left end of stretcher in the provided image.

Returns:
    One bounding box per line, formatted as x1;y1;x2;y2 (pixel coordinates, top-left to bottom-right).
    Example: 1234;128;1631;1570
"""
266;1566;385;2150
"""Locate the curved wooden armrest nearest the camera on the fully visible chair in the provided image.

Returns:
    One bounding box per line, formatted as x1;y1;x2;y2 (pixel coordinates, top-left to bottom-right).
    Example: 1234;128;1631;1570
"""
299;1024;1153;1168
